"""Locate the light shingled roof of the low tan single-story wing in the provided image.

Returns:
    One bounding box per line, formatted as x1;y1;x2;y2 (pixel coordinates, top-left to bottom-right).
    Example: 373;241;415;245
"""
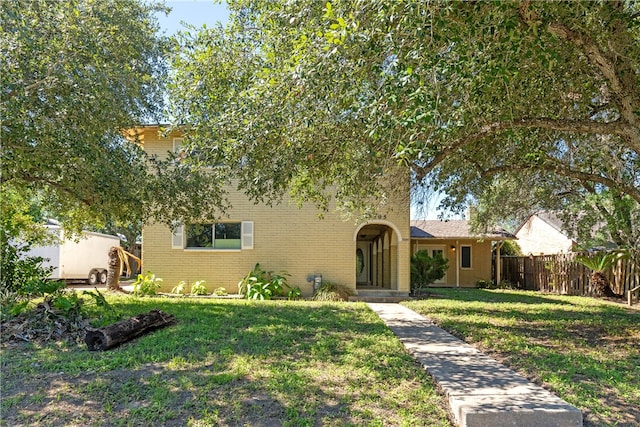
411;219;515;240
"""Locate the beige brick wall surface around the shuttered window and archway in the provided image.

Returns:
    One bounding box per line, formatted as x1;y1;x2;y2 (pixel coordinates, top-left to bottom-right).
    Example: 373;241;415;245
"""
137;128;410;296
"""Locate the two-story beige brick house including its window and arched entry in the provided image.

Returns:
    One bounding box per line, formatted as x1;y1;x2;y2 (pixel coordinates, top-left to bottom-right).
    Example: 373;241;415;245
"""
136;125;410;296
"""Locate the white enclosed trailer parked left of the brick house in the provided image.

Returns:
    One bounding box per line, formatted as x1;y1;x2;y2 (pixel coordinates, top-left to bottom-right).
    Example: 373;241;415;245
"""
27;225;120;286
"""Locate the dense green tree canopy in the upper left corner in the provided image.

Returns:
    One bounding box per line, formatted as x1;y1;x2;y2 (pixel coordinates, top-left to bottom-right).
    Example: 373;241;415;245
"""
0;0;226;237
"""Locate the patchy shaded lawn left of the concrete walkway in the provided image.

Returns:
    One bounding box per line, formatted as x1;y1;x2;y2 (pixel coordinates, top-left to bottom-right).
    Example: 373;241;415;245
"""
0;295;450;426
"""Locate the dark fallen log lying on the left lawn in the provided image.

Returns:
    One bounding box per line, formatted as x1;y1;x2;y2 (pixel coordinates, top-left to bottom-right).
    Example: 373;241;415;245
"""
84;310;176;351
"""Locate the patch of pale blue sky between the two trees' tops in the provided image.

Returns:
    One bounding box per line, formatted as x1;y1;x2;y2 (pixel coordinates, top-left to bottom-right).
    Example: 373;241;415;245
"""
158;0;229;35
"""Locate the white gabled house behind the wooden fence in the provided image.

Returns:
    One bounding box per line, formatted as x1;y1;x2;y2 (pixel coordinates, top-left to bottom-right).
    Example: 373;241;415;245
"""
515;212;577;255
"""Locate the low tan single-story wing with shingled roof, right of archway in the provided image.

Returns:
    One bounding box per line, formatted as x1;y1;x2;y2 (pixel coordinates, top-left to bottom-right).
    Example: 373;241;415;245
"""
411;220;514;287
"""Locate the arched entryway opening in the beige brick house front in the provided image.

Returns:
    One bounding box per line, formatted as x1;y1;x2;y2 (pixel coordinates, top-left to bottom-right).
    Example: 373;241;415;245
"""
355;223;398;289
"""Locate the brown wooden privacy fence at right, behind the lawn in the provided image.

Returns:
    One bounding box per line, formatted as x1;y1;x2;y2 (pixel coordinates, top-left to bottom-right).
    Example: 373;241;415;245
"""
501;251;640;296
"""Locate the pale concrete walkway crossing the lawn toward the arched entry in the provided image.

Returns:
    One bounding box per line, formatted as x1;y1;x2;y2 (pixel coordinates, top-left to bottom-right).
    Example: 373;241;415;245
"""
368;303;582;427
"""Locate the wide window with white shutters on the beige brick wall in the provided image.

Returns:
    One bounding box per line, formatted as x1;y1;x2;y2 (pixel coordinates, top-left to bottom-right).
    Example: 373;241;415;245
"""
171;221;253;250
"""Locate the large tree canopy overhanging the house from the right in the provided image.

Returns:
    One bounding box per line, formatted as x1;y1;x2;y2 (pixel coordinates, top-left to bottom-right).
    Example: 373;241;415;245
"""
171;0;640;244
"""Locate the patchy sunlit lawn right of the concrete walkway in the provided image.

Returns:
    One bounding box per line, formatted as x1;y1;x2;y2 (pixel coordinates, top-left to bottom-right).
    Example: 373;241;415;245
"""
406;289;640;426
